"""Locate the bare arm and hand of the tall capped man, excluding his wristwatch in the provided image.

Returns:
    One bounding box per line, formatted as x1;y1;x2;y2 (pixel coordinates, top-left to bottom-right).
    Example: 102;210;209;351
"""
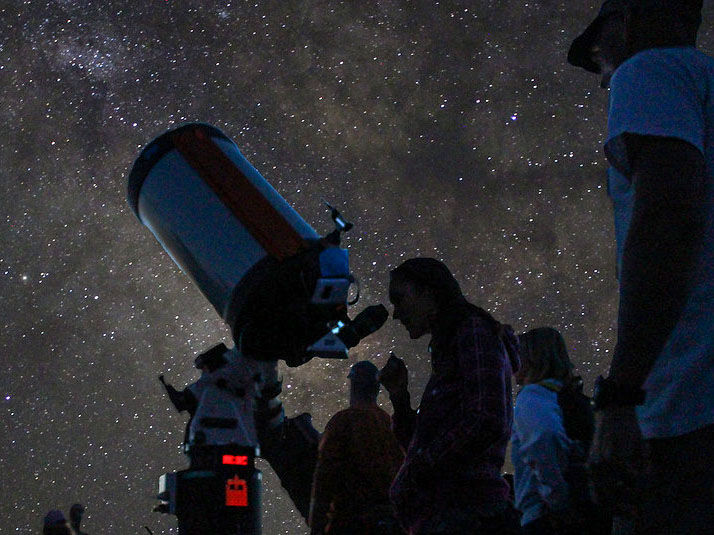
589;135;707;515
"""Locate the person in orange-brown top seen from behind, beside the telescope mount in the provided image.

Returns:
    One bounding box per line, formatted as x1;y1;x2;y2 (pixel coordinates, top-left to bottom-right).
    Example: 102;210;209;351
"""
308;360;404;535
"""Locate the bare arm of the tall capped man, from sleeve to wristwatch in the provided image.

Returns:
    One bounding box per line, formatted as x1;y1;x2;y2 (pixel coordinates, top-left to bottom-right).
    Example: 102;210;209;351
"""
610;134;707;389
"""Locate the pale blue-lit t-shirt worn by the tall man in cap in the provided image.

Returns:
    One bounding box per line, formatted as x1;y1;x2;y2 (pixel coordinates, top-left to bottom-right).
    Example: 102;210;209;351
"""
606;47;714;438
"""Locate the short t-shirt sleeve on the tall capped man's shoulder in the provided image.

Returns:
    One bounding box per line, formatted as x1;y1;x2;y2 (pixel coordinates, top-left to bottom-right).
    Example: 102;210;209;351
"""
605;49;706;178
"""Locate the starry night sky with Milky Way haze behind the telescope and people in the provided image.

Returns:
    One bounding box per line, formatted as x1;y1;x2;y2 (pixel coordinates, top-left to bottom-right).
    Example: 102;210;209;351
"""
0;0;714;535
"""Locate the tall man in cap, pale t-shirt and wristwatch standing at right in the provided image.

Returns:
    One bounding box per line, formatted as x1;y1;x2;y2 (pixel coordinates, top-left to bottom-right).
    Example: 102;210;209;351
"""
568;0;714;534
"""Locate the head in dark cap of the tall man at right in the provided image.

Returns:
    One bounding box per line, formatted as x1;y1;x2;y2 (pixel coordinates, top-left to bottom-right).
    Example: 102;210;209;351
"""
568;0;702;87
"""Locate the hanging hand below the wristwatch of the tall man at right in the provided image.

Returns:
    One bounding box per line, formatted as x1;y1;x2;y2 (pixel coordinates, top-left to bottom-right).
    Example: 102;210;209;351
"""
588;407;645;516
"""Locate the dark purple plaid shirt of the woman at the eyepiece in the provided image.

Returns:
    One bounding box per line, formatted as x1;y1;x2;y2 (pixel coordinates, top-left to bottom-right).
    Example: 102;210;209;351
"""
390;314;518;534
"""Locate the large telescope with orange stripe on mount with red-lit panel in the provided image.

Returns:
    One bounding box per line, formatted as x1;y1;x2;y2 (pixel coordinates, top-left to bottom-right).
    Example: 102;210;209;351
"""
128;123;388;535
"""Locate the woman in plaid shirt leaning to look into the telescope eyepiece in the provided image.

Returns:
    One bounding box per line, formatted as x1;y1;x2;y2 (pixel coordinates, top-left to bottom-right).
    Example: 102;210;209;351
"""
380;258;519;535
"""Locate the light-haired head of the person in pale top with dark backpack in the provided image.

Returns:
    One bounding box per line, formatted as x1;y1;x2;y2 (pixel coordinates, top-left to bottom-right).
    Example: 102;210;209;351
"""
516;327;573;384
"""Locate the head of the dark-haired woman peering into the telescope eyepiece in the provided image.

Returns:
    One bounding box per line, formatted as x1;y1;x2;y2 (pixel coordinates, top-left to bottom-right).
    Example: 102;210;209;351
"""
389;258;465;339
